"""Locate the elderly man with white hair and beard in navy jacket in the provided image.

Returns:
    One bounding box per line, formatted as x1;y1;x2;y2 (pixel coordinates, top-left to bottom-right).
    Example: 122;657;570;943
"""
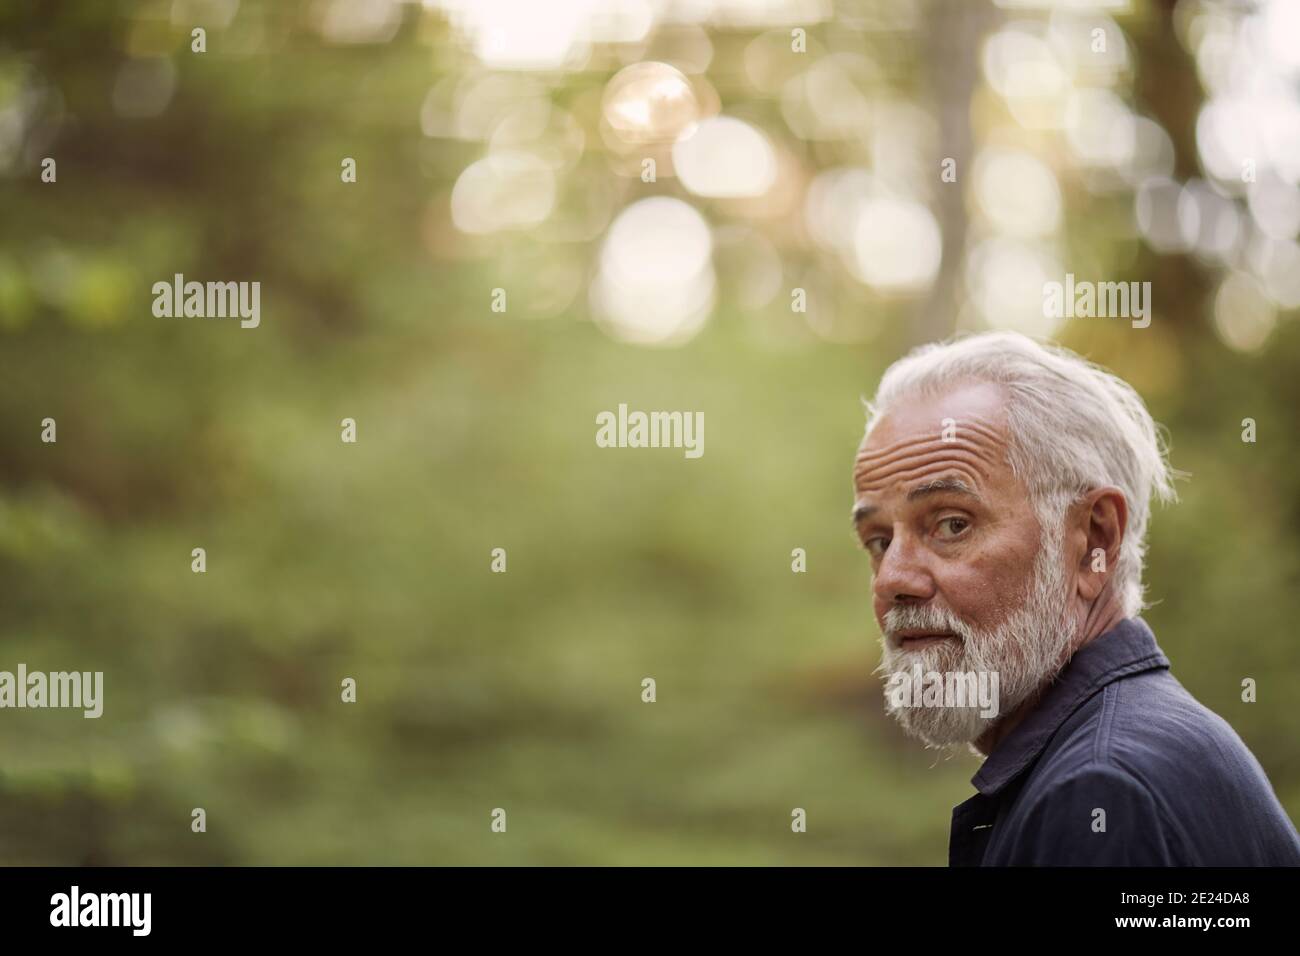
853;332;1300;866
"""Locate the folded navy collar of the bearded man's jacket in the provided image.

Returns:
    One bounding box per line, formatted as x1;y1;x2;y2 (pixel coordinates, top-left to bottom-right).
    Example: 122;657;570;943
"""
971;618;1169;796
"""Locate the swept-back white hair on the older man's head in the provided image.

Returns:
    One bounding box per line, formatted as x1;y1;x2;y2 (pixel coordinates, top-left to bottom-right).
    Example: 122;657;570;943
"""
866;332;1183;618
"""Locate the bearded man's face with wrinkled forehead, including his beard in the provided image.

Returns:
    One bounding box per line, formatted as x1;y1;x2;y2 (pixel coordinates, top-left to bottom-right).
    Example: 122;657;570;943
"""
854;382;1074;745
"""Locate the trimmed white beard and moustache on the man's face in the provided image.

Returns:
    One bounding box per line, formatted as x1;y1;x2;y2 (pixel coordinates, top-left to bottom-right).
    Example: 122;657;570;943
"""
876;520;1079;748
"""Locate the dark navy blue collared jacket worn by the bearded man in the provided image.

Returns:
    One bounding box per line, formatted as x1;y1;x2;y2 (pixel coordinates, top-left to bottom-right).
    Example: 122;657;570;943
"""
948;618;1300;866
